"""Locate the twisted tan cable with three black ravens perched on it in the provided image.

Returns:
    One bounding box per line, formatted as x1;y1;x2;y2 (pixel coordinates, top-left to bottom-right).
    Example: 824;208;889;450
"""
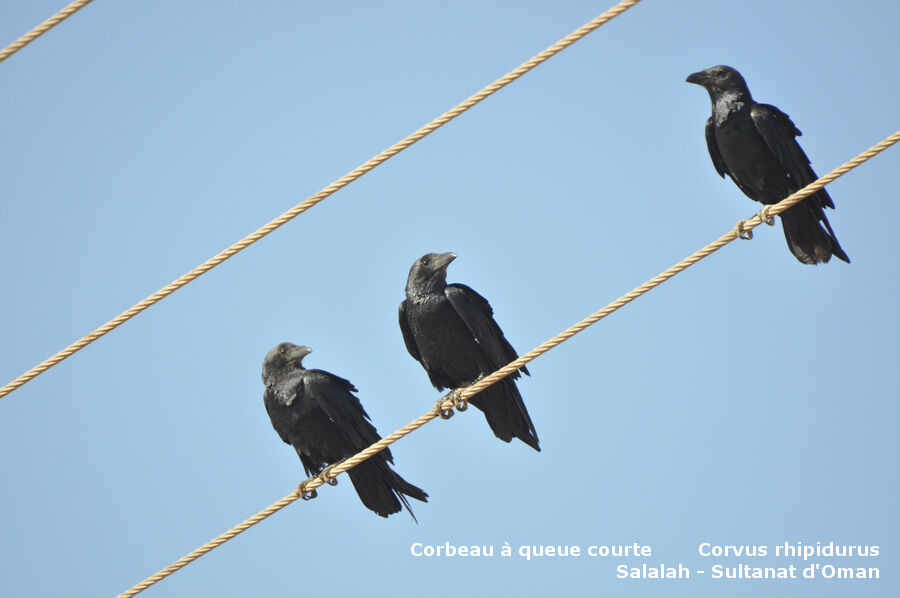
119;131;900;598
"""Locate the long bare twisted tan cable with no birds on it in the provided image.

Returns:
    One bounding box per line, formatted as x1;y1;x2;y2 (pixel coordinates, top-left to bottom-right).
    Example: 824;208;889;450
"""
0;0;641;398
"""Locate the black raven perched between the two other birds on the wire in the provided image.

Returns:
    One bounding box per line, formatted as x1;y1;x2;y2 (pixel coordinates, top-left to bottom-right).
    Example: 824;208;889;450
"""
400;253;541;451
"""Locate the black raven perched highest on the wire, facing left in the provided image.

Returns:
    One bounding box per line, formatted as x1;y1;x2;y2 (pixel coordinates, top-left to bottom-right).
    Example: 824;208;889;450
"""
687;66;850;264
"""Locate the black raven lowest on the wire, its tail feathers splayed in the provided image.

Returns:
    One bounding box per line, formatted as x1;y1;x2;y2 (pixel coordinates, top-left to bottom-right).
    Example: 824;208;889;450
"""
262;343;428;520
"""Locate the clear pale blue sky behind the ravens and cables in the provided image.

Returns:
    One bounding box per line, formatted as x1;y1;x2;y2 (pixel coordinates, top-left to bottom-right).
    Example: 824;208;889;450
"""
0;0;900;597
